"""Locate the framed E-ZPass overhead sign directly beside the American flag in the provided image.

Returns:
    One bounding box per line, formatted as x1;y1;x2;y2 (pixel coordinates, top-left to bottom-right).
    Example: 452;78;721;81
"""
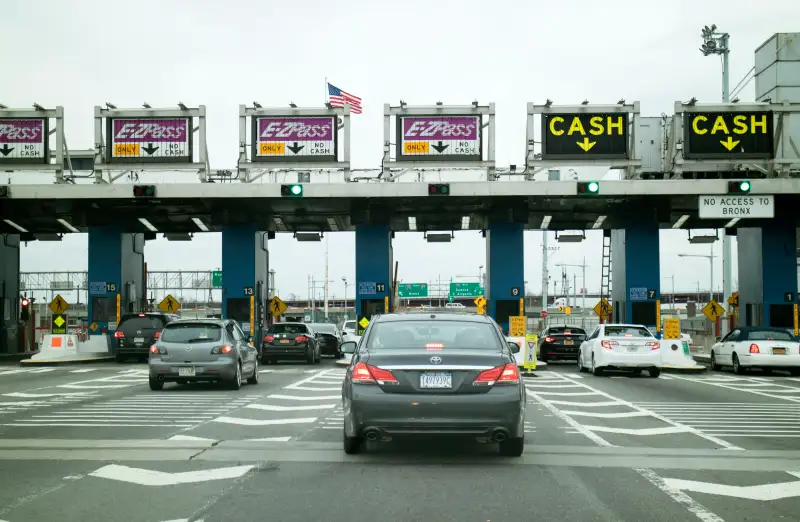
238;105;350;182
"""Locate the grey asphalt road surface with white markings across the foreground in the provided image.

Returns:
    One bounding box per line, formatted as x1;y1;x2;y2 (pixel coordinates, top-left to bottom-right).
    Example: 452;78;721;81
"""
0;359;800;522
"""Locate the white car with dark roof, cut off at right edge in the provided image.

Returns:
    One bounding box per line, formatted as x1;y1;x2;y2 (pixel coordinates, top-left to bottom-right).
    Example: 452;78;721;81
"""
711;326;800;376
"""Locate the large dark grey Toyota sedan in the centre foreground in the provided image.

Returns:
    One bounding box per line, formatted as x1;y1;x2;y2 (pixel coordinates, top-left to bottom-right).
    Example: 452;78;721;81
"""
342;312;526;456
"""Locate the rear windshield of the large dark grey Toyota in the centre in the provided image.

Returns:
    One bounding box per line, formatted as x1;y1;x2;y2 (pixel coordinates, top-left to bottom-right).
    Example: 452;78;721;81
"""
366;321;502;351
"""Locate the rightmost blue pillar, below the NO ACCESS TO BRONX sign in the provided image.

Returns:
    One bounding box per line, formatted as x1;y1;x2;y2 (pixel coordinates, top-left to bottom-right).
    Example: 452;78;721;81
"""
736;219;798;329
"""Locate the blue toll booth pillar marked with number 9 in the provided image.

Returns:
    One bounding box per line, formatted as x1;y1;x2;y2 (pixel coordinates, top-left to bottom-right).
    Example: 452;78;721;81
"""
484;221;525;334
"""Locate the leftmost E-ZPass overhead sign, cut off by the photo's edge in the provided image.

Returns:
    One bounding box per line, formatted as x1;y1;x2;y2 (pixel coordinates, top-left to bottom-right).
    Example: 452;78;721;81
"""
0;104;69;183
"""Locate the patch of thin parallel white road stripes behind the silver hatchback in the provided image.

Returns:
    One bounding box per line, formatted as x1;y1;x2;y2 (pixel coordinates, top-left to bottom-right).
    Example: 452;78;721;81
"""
5;393;258;428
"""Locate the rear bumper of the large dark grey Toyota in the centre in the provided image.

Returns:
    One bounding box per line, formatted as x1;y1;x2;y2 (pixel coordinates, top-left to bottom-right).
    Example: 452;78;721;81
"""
344;385;525;438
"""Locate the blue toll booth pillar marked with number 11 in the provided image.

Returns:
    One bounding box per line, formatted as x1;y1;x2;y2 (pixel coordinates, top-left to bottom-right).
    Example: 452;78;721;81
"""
356;224;394;335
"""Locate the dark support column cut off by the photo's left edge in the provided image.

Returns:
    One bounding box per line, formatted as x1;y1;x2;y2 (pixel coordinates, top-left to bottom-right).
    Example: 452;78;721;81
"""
0;234;20;353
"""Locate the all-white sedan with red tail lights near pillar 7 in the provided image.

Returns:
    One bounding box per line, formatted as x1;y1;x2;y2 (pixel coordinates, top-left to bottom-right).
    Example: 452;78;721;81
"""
578;324;662;377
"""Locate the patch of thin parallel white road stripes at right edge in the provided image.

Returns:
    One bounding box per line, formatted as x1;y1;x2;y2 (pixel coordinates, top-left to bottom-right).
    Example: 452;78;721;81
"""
637;402;800;439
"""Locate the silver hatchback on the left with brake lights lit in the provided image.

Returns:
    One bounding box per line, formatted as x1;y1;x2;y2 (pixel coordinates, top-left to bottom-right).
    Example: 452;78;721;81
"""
149;319;258;391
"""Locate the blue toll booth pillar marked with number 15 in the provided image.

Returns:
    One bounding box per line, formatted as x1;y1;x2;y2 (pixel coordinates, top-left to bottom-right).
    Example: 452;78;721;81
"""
87;226;147;338
